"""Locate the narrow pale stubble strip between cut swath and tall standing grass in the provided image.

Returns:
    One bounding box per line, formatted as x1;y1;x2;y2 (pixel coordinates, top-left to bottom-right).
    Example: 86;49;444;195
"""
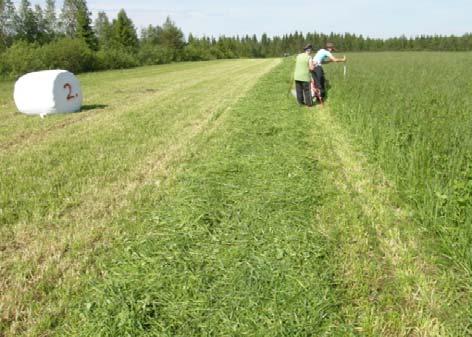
313;105;459;337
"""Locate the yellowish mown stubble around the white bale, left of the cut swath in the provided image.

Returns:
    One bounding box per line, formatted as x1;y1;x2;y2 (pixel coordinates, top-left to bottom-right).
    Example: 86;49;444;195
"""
0;60;279;335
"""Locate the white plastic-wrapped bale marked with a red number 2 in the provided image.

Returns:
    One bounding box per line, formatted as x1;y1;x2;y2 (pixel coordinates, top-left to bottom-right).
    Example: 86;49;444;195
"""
14;70;83;117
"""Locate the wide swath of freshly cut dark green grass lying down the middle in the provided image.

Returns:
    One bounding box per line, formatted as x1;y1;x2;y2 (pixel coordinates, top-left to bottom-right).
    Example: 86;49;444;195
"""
46;62;349;336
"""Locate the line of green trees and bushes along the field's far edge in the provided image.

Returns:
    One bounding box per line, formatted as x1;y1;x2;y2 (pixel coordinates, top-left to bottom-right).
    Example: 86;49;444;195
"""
0;0;472;77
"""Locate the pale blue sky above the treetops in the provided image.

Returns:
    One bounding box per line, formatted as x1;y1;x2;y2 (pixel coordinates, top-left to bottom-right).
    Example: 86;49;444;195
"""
15;0;472;38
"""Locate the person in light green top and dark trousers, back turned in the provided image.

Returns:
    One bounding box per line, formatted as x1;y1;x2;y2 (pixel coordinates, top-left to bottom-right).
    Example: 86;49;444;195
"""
293;44;313;106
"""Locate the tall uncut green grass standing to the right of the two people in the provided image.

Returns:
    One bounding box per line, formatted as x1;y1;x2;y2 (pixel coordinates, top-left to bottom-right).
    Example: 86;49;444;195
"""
328;53;472;276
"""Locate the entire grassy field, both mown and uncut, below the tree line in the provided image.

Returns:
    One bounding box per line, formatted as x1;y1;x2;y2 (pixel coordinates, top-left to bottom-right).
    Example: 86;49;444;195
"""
0;53;472;337
